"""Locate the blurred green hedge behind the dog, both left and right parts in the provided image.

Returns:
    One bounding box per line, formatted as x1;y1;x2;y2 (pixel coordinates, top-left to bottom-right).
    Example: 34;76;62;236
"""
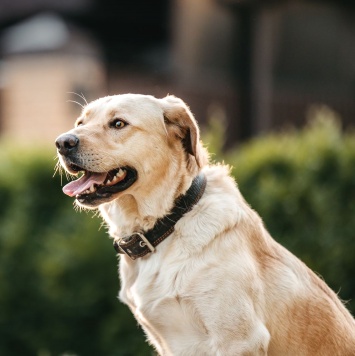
0;109;355;356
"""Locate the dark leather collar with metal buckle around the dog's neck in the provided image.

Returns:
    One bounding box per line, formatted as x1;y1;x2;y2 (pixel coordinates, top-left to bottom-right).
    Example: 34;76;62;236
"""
113;173;207;260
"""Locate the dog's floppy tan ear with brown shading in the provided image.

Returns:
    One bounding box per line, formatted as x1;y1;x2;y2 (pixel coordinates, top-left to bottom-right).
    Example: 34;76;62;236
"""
161;95;207;168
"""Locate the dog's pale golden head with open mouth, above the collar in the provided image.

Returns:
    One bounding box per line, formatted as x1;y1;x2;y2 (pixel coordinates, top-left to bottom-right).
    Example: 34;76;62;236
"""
56;94;207;207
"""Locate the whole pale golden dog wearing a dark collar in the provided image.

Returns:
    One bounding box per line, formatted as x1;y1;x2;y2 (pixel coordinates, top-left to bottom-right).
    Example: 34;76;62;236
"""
56;94;355;356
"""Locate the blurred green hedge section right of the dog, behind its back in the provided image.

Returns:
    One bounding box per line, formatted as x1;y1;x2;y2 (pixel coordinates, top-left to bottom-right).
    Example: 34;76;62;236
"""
206;107;355;314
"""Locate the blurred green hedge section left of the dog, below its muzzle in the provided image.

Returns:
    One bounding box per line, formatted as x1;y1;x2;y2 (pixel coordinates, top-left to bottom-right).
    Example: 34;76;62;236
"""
0;144;151;356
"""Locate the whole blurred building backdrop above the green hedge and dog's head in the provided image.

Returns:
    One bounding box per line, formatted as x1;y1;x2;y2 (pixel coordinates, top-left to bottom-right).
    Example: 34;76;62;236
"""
0;0;355;144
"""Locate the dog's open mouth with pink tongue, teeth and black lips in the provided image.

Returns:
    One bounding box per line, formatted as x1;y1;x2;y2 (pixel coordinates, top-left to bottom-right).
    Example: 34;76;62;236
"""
63;164;137;205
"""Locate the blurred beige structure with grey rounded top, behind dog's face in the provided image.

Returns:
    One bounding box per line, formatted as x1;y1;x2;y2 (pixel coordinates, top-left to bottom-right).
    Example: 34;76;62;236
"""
1;13;106;142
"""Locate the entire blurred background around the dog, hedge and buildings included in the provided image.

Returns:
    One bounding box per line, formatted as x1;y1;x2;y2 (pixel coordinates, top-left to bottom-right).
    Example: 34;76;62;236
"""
0;0;355;356
